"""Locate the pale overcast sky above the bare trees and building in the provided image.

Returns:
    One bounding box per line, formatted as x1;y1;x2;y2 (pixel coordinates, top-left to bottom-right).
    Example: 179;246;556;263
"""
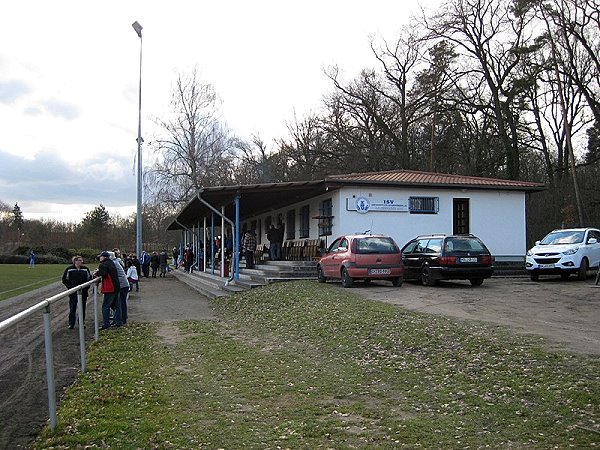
0;0;435;221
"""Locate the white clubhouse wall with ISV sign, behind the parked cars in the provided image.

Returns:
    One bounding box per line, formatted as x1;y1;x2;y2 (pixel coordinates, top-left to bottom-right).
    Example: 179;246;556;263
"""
239;187;526;259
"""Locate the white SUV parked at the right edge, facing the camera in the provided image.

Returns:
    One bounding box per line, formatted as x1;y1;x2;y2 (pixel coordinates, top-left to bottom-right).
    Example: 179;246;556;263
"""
525;228;600;281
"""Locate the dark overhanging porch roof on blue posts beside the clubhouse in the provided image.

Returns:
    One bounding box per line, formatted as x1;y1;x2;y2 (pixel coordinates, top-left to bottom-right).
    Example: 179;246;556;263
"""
167;180;329;230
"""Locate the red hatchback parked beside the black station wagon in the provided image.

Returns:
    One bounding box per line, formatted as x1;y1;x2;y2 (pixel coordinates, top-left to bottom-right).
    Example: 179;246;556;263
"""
317;234;404;287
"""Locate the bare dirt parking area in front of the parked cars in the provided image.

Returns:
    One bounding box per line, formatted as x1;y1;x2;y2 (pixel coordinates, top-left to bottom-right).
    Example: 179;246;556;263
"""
355;277;600;355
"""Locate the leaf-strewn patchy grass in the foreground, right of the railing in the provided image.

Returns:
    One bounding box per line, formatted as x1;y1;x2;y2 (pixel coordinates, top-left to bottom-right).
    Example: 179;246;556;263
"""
35;282;600;449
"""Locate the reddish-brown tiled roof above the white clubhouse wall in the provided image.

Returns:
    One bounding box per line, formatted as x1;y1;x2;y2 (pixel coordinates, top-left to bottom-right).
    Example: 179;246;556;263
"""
326;170;545;191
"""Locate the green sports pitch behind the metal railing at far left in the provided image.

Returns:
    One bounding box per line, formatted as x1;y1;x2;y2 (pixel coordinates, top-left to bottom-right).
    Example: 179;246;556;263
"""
0;264;67;300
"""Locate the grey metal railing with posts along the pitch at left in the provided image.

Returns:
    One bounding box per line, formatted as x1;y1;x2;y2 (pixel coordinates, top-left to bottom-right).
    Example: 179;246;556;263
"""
0;277;101;431
